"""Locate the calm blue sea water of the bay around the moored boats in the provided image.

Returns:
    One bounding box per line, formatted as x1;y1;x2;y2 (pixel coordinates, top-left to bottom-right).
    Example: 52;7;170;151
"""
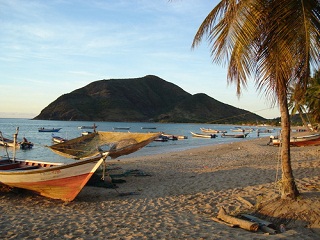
0;118;278;162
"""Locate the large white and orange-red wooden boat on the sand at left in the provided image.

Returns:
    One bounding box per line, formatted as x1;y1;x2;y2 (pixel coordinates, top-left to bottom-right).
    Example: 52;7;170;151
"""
0;157;107;201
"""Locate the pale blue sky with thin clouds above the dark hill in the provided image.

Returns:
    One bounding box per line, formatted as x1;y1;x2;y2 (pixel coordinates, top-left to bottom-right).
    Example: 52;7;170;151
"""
0;0;280;119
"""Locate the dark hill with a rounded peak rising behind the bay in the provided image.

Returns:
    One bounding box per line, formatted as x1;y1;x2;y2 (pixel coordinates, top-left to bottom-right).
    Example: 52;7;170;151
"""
35;75;264;123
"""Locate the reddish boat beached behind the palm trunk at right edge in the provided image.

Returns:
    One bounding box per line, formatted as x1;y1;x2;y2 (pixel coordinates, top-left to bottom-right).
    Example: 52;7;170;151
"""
272;134;320;147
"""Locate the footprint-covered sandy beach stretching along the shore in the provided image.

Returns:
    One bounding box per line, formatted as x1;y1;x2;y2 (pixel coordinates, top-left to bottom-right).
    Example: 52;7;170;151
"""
0;134;320;239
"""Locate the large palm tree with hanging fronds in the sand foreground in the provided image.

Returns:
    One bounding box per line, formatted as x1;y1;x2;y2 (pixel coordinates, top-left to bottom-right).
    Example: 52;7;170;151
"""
192;0;320;199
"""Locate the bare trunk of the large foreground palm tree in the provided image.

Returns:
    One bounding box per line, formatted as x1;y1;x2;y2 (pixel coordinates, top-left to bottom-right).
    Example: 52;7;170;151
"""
279;93;299;199
